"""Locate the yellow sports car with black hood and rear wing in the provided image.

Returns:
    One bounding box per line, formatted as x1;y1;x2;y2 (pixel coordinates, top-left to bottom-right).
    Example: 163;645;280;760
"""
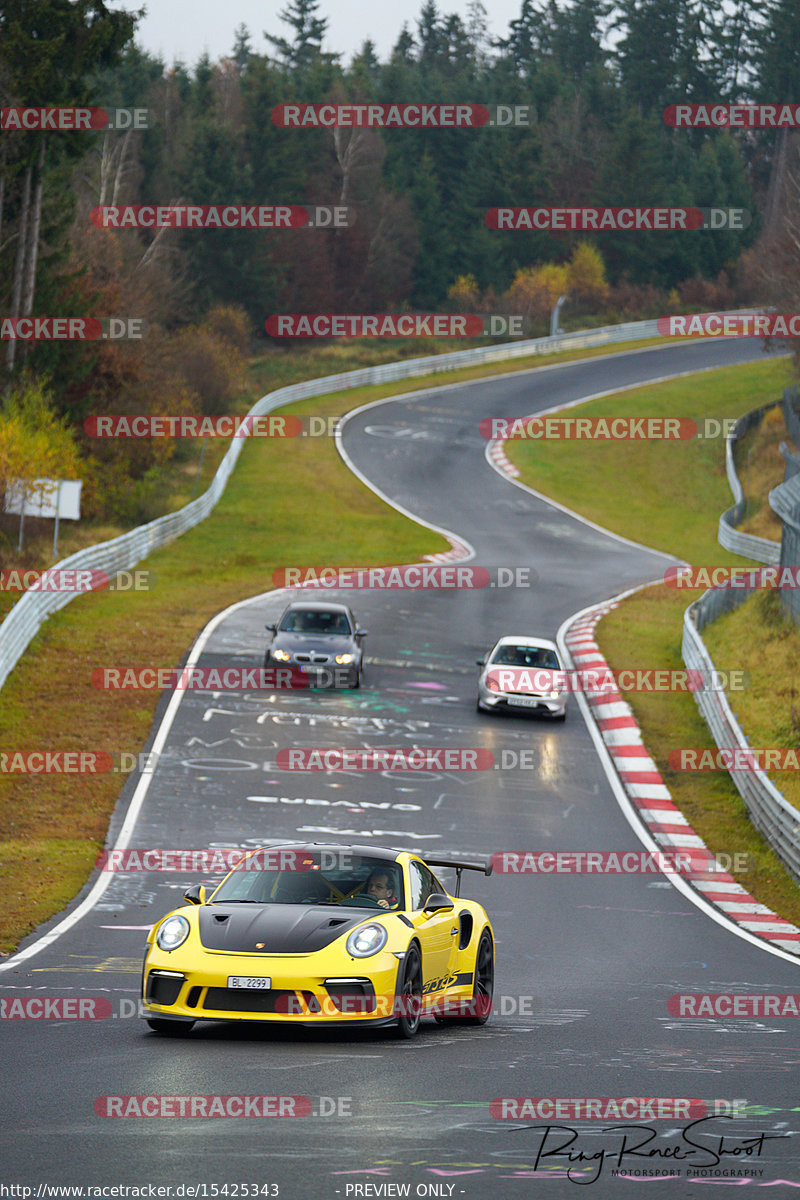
142;842;494;1038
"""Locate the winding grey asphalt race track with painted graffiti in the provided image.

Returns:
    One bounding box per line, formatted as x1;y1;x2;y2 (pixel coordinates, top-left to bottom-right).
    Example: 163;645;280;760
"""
0;338;800;1200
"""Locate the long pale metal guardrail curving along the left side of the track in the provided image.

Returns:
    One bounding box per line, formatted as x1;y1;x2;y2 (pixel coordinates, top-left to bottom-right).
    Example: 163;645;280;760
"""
0;320;660;688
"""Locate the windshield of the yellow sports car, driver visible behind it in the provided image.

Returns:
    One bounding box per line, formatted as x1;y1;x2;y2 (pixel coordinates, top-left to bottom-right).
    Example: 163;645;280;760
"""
210;847;405;912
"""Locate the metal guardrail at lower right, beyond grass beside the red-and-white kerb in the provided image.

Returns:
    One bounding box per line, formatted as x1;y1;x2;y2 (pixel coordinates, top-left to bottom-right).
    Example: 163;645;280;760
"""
681;597;800;882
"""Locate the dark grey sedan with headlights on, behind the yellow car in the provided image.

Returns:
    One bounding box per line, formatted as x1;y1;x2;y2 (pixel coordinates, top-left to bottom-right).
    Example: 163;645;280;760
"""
264;600;367;688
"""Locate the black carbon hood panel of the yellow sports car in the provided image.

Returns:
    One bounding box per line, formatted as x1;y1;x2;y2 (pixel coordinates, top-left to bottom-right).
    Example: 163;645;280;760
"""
198;904;365;954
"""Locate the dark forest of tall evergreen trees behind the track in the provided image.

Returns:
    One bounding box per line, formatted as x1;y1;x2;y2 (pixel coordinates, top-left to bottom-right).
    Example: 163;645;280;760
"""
0;0;800;496
